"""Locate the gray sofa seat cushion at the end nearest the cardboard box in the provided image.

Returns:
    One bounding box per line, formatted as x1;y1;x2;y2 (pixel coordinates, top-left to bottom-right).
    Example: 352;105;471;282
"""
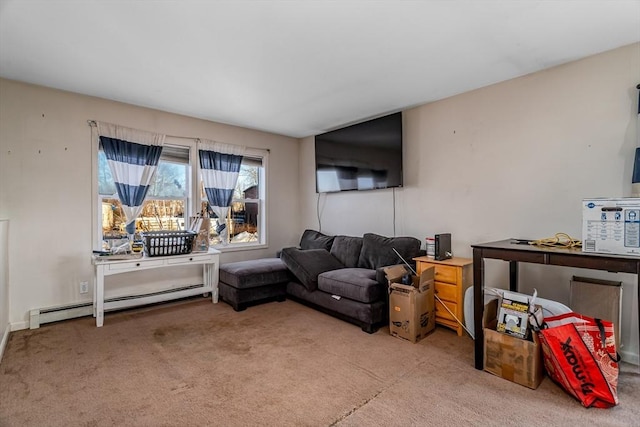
318;268;383;304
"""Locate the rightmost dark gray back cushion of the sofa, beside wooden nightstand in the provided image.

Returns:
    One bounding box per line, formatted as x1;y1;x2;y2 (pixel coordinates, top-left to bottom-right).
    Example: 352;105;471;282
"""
358;233;421;270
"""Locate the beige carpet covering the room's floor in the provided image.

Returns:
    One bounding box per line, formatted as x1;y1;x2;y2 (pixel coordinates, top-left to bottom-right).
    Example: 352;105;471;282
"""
0;298;640;426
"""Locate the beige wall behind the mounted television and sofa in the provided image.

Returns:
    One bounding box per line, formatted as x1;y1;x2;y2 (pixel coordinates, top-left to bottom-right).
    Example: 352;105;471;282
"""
300;44;640;363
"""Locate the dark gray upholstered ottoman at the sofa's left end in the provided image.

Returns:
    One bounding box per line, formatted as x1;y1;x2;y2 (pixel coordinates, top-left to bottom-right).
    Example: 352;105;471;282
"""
218;258;291;311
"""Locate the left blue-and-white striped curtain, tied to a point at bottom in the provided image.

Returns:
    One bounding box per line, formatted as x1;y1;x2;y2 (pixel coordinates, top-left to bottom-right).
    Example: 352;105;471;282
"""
97;123;164;236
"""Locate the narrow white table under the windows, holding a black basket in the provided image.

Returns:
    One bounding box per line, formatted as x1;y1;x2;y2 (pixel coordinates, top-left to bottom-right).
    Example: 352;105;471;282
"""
93;249;220;327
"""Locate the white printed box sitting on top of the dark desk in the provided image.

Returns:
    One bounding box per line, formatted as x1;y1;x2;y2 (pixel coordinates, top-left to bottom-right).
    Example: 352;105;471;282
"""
582;197;640;256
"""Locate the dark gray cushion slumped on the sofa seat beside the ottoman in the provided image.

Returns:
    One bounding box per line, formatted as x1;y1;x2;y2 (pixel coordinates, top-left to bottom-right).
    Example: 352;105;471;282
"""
280;248;344;291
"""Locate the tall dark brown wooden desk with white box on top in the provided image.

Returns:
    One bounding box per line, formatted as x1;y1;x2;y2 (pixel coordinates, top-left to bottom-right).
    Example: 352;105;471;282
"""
471;239;640;369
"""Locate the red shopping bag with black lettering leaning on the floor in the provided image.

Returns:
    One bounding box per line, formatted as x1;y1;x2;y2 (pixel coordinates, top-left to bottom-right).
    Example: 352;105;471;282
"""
539;313;620;408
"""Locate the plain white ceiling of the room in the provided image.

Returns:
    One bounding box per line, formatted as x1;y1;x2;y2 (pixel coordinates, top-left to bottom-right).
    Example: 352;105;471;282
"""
0;0;640;137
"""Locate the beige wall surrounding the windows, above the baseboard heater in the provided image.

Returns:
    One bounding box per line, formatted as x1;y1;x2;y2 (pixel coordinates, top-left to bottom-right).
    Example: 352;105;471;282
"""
0;79;300;328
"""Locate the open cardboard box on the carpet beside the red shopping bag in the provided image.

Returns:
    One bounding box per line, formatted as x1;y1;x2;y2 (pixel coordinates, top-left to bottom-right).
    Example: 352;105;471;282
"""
482;300;544;389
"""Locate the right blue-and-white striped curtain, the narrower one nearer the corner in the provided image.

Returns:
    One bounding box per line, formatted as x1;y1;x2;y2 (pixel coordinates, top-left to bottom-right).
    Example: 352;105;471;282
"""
198;143;244;245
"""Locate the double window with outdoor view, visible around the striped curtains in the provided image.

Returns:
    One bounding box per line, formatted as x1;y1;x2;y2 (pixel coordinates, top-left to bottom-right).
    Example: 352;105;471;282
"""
96;138;266;251
